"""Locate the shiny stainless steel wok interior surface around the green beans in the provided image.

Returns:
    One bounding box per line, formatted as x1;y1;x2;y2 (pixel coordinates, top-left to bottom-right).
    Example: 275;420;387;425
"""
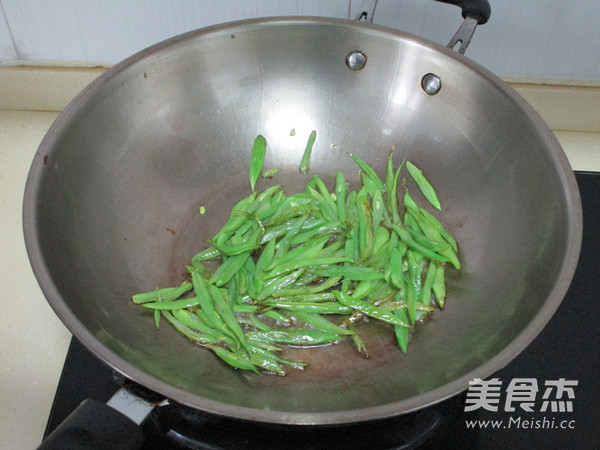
31;20;571;423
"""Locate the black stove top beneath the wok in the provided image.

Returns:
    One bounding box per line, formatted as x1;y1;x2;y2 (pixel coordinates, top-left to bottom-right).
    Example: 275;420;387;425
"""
45;172;600;450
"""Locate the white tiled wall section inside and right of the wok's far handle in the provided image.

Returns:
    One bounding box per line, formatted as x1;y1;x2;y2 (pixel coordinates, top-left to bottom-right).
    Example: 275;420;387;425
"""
368;0;600;81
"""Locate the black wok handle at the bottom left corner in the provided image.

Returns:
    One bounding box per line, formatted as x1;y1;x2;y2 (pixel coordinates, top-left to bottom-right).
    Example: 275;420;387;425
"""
38;399;144;450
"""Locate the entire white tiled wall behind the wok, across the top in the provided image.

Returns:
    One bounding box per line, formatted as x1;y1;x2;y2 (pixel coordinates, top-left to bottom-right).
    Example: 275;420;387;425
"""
0;0;600;83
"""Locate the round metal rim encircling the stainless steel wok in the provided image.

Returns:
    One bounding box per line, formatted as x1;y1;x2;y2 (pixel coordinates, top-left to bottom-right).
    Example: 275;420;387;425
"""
23;16;583;425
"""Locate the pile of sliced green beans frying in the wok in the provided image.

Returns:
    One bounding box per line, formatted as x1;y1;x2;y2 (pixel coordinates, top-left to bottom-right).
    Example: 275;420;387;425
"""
133;135;460;374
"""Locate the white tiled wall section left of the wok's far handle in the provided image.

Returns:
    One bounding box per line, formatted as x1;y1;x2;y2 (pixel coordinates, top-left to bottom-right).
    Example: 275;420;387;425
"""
0;0;349;64
